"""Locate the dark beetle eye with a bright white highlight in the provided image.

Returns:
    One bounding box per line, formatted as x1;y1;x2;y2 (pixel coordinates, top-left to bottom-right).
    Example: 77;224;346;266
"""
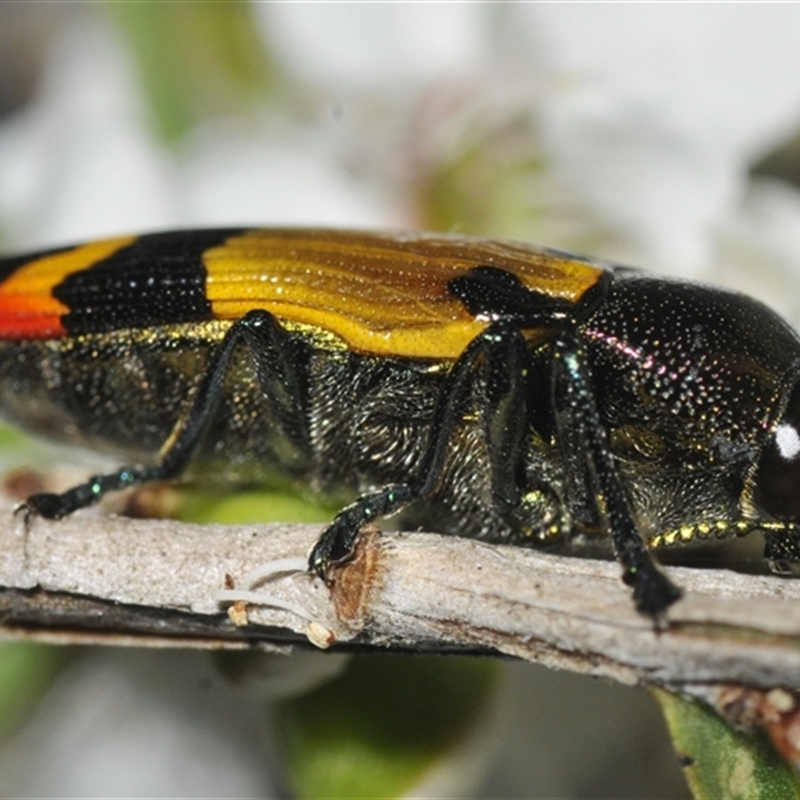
754;383;800;519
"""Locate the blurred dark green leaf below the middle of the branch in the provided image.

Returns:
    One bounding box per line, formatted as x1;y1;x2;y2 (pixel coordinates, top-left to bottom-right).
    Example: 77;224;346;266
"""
275;656;501;798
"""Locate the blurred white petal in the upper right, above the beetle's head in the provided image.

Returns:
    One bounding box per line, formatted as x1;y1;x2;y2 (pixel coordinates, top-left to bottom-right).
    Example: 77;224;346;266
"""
516;3;800;275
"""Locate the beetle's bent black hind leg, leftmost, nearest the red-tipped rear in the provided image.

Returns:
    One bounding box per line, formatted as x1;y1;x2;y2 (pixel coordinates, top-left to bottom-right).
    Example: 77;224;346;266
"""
20;310;308;519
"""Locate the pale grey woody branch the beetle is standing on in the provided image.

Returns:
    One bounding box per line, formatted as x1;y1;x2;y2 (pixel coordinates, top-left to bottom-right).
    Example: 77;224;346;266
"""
0;510;800;702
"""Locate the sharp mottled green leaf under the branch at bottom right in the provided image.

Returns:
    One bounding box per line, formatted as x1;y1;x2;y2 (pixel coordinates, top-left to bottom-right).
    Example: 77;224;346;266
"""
653;689;800;800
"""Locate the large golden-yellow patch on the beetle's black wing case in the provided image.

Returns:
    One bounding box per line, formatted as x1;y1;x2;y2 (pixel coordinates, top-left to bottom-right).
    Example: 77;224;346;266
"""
203;229;604;360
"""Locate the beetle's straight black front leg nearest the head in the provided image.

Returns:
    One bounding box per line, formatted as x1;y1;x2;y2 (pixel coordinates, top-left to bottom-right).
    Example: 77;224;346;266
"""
553;333;681;617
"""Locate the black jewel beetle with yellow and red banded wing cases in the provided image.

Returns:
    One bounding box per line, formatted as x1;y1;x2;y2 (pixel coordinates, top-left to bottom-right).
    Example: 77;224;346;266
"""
0;229;800;617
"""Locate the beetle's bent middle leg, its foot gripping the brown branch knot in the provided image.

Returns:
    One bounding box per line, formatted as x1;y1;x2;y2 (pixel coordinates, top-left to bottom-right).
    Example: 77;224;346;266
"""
309;321;530;577
